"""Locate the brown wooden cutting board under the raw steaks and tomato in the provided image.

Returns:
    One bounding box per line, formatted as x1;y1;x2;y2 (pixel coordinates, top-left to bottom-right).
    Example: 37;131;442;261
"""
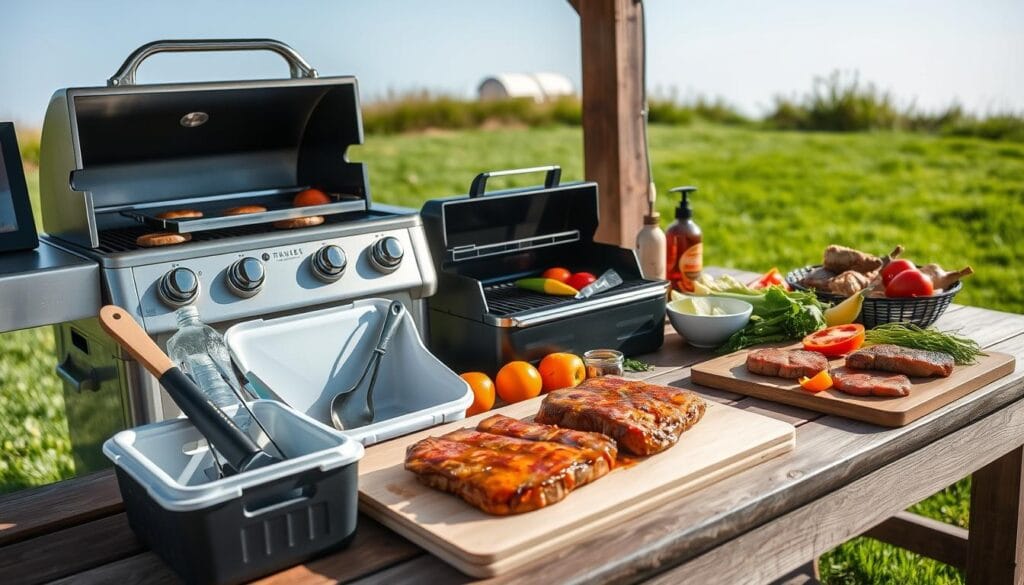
690;344;1016;426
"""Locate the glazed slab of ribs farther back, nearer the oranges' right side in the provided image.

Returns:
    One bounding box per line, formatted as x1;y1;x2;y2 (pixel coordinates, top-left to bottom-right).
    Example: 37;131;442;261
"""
535;377;707;455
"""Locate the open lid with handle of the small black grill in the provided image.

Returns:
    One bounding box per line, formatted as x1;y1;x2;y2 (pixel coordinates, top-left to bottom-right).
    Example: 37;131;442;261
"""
421;166;598;263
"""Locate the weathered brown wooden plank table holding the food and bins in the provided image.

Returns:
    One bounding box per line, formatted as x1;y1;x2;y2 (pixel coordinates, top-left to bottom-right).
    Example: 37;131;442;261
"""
0;271;1024;585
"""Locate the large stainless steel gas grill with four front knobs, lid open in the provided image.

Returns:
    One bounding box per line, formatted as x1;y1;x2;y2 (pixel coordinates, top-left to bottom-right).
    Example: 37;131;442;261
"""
40;39;436;472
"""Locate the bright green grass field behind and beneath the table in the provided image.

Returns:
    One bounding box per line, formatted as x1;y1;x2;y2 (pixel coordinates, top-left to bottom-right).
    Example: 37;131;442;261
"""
0;124;1024;584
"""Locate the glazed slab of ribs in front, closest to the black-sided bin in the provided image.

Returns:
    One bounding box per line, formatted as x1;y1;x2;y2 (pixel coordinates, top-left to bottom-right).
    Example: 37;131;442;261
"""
406;417;615;515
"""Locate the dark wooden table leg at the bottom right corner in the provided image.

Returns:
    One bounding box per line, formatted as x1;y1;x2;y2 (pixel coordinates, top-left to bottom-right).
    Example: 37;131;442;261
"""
966;448;1024;585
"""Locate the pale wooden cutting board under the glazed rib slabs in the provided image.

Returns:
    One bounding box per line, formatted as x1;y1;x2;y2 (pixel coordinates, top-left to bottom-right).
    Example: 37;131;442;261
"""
359;398;796;577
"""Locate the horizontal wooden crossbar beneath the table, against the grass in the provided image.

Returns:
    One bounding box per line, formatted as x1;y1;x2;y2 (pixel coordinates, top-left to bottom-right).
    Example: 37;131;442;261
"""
863;512;968;570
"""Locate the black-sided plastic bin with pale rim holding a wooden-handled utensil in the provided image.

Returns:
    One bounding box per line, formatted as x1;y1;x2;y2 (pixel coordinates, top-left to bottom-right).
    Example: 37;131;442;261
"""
103;401;362;584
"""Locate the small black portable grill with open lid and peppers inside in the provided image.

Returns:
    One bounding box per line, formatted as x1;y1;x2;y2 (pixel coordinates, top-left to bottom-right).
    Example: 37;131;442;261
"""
421;167;668;374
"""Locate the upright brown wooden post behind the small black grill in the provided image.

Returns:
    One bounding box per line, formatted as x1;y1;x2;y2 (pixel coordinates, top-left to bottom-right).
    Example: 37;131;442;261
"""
575;0;649;248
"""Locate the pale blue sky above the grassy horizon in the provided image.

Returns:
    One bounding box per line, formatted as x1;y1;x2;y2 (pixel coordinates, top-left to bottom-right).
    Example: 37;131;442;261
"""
0;0;1024;125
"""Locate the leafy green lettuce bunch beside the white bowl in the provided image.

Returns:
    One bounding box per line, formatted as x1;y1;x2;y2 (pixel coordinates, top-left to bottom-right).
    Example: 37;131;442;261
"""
714;286;825;353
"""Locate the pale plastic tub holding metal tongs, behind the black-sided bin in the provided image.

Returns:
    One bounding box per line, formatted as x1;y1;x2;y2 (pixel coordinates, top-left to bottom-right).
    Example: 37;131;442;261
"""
224;298;473;445
